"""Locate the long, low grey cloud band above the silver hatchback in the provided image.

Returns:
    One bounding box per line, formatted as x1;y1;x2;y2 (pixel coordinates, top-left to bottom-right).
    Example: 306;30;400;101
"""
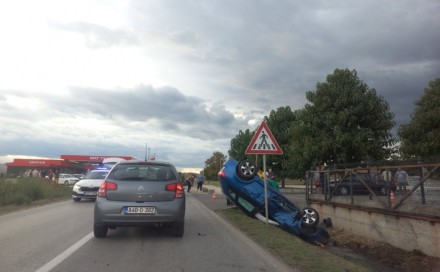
38;86;248;139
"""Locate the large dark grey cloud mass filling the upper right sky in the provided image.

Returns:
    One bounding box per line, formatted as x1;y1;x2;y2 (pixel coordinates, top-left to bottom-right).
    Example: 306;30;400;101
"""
127;1;440;127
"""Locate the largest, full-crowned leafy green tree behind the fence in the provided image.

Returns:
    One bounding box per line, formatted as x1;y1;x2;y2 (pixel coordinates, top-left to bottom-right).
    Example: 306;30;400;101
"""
289;69;395;171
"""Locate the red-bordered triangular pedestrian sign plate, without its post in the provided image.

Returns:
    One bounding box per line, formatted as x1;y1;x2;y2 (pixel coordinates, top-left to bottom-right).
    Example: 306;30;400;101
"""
245;121;283;155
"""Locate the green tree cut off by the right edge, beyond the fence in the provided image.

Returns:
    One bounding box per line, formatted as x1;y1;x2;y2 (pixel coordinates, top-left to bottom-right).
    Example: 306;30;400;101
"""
397;78;440;158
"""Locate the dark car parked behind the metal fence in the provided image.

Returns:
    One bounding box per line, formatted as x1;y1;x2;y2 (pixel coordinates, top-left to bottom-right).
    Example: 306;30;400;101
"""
329;173;395;195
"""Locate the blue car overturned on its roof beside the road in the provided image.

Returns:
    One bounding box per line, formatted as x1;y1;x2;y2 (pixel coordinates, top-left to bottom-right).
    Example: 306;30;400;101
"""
218;159;330;245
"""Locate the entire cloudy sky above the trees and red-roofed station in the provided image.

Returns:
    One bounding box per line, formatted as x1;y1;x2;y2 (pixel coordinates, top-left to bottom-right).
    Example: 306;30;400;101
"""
0;0;440;171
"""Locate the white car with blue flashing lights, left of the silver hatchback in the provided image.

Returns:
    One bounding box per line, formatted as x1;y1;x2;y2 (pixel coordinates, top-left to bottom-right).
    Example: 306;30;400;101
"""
72;170;110;201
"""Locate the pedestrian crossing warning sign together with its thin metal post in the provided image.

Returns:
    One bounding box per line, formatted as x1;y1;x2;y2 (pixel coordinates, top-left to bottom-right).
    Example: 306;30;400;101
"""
245;121;283;223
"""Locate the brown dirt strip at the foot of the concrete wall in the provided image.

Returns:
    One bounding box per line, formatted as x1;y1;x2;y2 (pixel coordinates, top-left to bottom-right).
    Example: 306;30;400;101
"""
327;227;440;272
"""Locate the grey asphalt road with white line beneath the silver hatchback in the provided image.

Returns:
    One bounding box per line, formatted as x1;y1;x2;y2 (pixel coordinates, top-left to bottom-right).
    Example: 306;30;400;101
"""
0;192;292;272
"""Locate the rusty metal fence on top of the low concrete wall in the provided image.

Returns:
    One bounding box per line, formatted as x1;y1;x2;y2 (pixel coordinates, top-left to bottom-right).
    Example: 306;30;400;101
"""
305;163;440;218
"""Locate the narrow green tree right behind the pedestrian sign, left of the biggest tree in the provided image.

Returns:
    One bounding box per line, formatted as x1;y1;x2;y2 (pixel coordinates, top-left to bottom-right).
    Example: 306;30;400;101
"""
264;106;296;187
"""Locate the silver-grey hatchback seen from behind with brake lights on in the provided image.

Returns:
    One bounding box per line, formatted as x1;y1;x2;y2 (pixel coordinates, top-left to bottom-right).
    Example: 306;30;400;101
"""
93;160;186;238
